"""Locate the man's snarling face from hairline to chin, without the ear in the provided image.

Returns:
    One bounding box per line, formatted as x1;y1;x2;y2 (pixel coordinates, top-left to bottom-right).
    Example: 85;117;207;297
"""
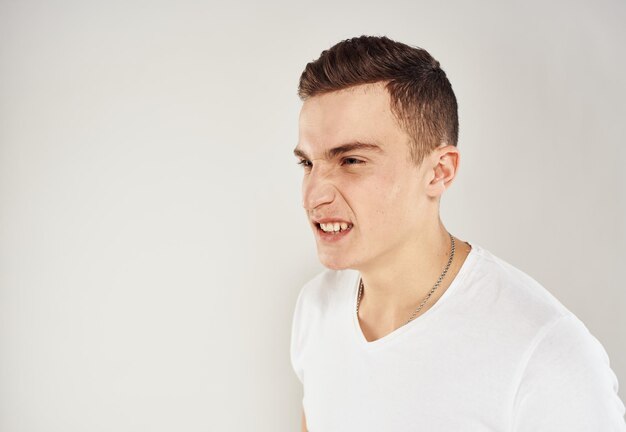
295;83;438;269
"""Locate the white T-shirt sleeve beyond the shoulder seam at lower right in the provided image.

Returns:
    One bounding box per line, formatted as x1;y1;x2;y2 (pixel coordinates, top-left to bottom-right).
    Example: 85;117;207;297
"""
512;314;626;432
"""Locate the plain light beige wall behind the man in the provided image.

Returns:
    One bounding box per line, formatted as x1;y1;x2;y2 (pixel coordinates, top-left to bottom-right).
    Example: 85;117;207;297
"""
0;0;626;432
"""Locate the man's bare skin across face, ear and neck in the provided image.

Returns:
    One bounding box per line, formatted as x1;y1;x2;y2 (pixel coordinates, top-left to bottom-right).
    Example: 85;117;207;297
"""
294;83;470;430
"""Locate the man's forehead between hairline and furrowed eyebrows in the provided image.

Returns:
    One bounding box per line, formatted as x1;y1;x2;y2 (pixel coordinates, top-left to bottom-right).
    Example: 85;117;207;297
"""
298;83;408;151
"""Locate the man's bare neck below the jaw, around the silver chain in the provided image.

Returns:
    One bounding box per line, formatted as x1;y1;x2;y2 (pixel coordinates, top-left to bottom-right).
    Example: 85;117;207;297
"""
358;219;461;324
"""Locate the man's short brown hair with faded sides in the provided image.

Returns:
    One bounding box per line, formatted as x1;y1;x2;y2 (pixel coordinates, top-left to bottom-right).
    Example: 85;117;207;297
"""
298;35;459;165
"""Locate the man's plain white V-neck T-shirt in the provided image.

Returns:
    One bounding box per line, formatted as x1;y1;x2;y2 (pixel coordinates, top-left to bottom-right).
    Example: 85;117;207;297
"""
291;244;626;432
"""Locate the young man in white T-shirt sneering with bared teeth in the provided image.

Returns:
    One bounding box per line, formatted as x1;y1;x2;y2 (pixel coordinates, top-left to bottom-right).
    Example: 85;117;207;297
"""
291;36;626;432
